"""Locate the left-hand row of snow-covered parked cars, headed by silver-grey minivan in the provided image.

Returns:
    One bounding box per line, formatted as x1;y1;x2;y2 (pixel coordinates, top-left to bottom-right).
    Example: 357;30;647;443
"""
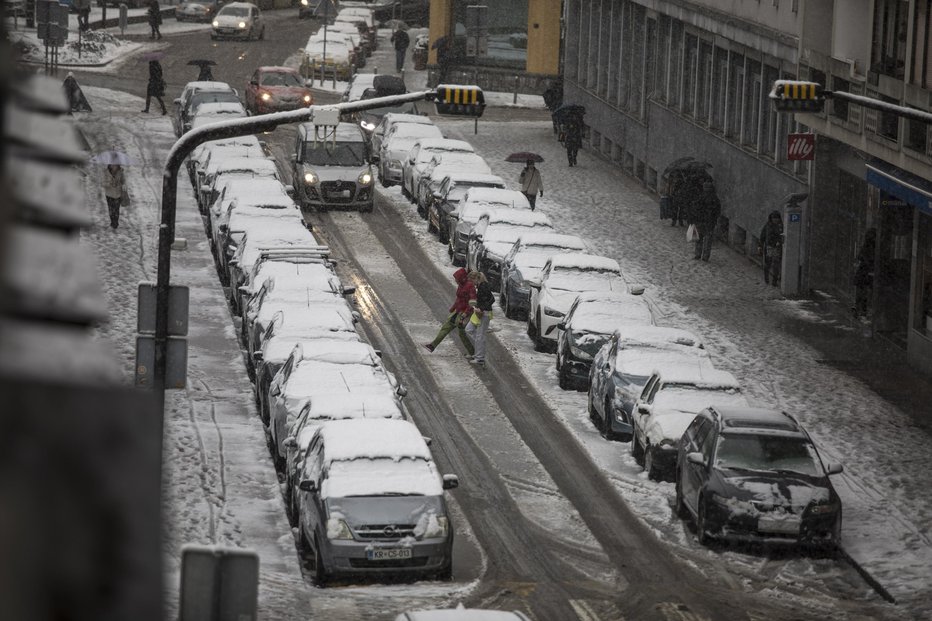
186;71;458;584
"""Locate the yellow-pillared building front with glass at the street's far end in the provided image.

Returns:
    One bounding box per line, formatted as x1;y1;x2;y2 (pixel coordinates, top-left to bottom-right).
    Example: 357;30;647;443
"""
428;0;562;93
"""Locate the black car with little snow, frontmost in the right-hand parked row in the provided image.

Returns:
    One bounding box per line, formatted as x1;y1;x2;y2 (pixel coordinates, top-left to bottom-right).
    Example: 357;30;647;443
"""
676;407;842;548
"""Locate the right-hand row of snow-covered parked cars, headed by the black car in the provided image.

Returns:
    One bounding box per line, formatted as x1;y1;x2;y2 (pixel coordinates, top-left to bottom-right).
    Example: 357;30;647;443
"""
382;110;842;547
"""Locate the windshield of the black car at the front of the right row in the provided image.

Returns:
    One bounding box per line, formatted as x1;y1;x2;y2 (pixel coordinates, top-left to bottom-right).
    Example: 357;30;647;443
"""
715;433;823;476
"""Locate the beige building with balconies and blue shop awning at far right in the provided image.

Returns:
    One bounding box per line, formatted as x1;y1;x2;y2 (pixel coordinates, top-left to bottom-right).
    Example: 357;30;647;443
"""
797;0;932;373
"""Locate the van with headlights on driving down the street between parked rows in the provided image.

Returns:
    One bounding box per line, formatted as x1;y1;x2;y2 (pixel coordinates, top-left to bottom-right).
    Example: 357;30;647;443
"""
292;123;373;211
